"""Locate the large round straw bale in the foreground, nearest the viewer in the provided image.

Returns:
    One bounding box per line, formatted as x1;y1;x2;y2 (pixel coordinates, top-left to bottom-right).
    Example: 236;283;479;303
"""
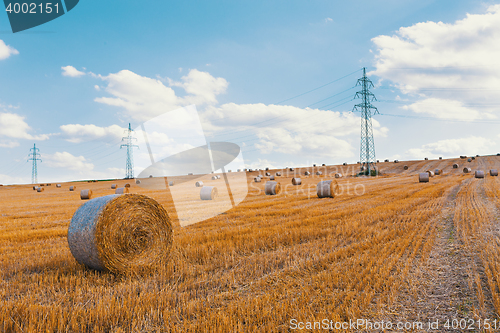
68;194;172;273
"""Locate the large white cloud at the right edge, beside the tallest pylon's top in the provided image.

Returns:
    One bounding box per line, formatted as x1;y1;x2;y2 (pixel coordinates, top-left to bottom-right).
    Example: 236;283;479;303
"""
370;5;500;120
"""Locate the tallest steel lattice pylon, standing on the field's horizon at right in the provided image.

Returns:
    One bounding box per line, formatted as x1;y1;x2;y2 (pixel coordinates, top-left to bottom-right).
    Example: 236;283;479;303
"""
353;67;379;175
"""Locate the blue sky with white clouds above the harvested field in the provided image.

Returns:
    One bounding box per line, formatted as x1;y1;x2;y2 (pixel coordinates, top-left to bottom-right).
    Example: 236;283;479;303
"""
0;0;500;184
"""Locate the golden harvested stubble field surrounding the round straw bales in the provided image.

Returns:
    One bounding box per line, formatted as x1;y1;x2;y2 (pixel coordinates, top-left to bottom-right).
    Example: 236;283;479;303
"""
0;156;500;332
